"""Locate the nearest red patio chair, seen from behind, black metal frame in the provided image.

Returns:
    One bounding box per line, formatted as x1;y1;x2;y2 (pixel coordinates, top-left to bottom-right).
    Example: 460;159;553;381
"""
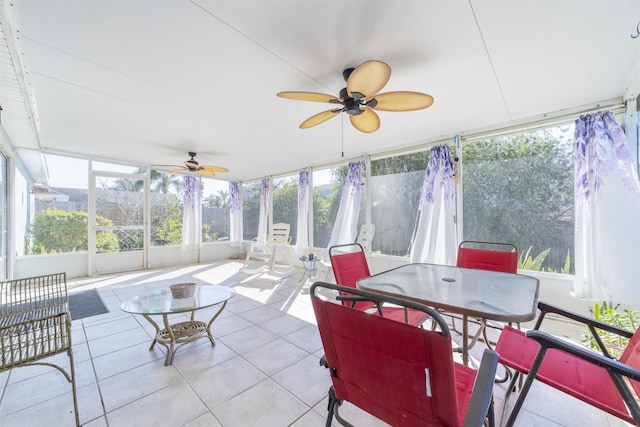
310;282;498;427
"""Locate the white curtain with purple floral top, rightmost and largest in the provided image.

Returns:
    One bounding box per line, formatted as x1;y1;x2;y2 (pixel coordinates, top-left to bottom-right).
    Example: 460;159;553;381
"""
573;111;640;303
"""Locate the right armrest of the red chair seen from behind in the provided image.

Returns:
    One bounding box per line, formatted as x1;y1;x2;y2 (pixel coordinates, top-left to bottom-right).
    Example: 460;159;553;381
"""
462;349;499;427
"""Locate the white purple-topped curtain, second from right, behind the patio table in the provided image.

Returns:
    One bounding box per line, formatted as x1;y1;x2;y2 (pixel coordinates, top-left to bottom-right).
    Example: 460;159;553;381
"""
410;145;457;265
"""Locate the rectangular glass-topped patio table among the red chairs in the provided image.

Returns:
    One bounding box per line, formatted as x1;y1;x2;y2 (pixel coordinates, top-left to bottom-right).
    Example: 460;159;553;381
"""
357;264;539;365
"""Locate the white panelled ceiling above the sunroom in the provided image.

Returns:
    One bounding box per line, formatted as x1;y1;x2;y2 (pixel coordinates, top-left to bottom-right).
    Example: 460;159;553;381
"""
0;0;640;181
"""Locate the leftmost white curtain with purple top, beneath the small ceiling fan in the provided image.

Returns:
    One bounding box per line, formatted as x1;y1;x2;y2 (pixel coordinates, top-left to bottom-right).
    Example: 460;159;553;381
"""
182;176;202;249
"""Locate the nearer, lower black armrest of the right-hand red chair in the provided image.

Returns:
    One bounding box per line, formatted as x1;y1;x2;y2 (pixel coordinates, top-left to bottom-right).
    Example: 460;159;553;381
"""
526;329;640;381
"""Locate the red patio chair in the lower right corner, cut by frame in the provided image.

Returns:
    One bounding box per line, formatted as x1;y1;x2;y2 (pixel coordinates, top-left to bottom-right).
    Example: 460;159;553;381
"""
496;302;640;426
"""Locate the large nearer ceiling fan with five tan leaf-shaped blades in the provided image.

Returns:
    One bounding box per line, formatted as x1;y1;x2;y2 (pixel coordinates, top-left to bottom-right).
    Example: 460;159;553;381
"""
277;60;433;133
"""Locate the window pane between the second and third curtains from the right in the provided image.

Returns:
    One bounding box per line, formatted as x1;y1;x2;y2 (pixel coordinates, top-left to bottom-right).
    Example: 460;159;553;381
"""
369;150;430;256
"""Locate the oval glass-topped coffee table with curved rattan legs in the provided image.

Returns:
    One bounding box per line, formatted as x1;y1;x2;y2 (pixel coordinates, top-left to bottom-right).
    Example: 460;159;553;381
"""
120;285;235;366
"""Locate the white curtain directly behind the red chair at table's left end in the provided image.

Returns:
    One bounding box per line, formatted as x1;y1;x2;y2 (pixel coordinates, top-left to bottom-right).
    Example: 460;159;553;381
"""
327;162;364;248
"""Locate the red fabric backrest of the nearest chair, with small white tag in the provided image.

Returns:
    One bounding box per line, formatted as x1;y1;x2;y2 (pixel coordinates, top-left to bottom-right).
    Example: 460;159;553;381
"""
312;298;462;426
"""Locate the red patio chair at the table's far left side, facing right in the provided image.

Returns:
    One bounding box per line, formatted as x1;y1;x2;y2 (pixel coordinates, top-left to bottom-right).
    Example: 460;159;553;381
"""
329;243;428;325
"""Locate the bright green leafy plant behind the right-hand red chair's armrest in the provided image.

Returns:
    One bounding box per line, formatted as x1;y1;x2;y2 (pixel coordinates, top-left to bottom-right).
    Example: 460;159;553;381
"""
582;301;640;358
